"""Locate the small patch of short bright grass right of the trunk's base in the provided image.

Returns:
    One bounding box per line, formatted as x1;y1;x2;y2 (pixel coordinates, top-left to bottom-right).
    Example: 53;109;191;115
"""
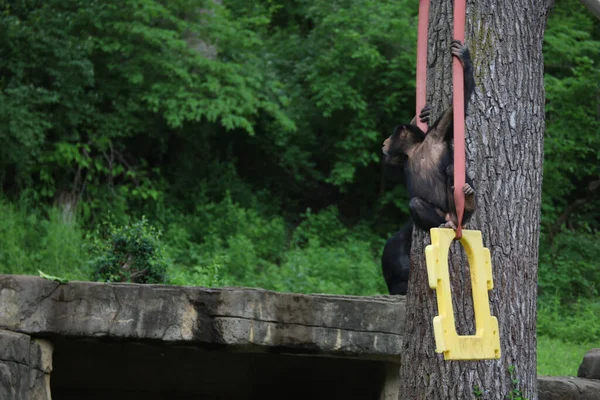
537;336;600;376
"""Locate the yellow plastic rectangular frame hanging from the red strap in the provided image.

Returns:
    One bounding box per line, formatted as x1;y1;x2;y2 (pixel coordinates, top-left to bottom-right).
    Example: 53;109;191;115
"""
425;228;500;360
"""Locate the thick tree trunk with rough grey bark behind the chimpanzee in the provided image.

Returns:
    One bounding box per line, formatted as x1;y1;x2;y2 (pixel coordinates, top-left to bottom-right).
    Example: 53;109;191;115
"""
399;0;553;400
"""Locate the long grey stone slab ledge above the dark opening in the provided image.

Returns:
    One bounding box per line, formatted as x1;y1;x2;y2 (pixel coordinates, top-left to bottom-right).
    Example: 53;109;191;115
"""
0;275;405;362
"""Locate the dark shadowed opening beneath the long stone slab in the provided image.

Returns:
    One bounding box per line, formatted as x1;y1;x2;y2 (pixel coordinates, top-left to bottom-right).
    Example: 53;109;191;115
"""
50;339;397;400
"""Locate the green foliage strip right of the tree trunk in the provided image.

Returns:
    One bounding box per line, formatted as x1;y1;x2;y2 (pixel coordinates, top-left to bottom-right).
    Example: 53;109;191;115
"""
538;0;600;350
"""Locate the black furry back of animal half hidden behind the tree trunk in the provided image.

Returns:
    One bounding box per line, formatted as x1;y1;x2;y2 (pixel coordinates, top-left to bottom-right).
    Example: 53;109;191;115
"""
381;220;413;295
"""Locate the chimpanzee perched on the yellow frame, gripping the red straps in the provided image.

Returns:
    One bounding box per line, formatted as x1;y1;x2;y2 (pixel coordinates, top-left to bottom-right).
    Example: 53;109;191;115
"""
382;40;476;231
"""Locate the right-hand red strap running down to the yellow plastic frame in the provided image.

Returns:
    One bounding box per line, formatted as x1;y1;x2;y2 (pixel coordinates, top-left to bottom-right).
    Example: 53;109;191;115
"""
452;0;467;239
